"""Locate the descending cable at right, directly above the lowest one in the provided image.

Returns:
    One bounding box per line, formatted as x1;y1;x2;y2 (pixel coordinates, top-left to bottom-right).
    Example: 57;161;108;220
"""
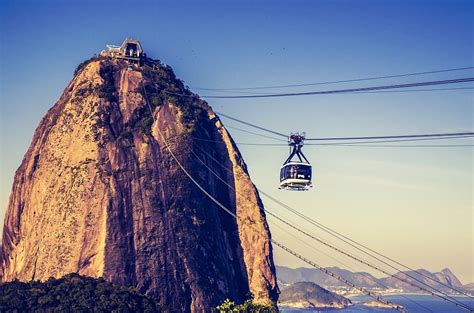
188;143;471;310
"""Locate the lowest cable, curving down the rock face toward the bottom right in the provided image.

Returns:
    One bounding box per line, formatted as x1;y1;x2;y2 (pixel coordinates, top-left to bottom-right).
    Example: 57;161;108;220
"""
142;87;406;313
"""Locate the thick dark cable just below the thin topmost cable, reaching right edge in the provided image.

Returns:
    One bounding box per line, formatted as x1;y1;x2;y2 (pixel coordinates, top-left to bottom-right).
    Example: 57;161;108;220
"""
165;77;474;99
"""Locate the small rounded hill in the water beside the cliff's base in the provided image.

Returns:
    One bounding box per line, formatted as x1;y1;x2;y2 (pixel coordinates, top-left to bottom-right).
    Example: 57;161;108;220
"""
278;282;352;309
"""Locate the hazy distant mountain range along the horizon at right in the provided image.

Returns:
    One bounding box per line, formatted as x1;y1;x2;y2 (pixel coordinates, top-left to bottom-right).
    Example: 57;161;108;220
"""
276;266;474;292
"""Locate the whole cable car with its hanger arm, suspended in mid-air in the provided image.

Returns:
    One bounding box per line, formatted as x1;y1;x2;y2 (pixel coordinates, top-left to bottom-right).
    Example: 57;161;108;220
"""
279;133;313;191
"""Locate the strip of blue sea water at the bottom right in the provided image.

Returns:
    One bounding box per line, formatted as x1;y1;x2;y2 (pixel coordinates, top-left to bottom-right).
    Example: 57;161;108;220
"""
280;295;474;313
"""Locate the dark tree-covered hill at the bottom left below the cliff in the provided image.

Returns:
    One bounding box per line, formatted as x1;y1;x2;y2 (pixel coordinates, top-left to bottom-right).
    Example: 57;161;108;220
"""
0;274;166;312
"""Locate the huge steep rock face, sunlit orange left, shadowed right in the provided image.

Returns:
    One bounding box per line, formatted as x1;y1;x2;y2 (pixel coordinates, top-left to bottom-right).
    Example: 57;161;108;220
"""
0;58;278;312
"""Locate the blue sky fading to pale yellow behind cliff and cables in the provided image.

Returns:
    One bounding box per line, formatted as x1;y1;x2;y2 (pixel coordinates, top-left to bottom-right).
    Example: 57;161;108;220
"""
0;1;474;283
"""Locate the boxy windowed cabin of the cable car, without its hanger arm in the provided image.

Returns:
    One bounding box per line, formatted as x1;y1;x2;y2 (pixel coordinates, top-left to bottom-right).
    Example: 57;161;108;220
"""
280;162;312;190
